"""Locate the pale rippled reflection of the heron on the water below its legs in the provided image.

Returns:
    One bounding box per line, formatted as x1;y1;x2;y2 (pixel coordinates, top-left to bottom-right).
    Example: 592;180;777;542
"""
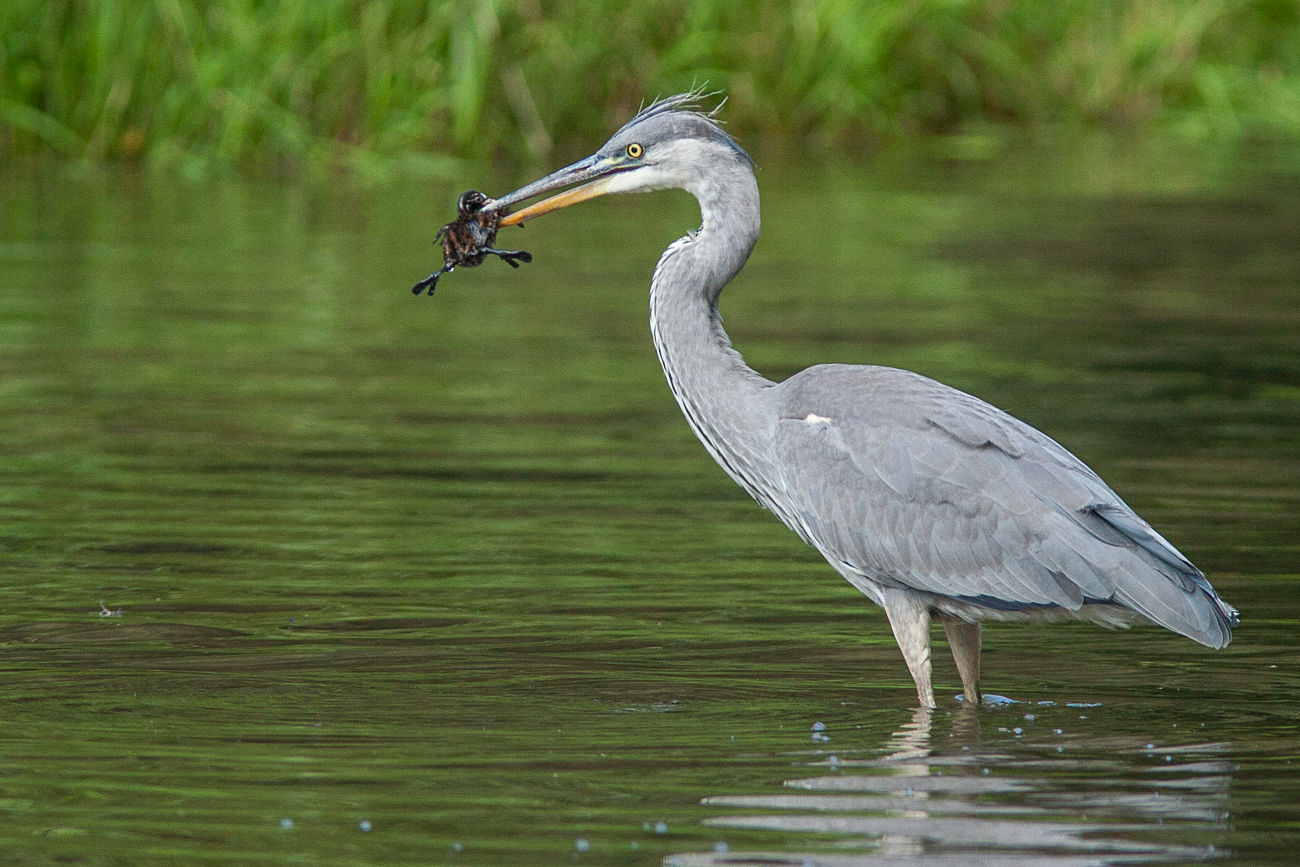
667;708;1232;867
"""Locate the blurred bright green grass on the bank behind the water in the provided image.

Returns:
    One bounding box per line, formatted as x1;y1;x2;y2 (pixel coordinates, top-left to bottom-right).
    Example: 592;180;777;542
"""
0;0;1300;173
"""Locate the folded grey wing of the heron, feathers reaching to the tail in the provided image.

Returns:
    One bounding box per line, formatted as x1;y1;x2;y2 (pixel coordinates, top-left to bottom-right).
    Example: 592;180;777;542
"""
774;365;1236;647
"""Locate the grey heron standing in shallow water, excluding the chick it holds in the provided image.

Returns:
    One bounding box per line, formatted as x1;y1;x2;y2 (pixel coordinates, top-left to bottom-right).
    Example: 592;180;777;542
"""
486;94;1238;707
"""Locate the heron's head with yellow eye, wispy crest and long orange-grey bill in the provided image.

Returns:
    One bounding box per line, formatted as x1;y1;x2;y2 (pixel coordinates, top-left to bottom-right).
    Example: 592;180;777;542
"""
485;92;751;226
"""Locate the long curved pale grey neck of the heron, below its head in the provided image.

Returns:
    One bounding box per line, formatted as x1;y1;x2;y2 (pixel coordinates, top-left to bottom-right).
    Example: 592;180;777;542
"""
650;165;774;502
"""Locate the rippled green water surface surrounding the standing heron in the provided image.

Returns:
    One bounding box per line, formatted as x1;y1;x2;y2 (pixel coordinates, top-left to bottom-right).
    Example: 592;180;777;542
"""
0;141;1300;866
